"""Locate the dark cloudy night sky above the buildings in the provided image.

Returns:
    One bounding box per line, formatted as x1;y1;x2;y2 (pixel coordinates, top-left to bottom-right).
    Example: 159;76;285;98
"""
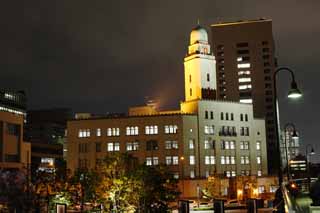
0;0;320;158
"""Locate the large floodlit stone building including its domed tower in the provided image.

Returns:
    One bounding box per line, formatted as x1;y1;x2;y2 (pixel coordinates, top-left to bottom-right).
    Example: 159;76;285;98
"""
67;26;267;179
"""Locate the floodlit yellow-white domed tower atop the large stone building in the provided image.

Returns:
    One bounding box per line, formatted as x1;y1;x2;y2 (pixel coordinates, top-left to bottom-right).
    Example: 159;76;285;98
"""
184;25;216;101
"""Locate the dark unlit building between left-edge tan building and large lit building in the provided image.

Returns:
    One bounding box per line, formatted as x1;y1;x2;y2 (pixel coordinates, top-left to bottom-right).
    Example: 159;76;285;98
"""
25;108;72;176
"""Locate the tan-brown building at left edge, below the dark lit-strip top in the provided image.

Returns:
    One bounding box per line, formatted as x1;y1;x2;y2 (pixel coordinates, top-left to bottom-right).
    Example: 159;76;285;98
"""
0;111;31;172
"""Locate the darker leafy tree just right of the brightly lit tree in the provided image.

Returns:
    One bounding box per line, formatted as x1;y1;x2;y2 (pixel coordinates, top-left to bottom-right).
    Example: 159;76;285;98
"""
136;165;180;212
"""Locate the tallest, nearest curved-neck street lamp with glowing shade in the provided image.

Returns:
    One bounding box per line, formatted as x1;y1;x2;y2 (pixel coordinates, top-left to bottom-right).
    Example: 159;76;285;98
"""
273;67;302;187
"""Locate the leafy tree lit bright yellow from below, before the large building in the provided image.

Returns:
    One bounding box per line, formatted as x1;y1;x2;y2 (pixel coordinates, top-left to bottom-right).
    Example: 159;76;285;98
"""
96;153;142;213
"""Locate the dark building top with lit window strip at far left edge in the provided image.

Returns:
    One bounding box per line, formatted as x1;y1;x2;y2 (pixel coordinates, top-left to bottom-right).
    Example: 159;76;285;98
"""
0;89;27;116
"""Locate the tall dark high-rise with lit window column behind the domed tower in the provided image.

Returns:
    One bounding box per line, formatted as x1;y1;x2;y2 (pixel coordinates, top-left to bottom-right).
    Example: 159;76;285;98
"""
211;19;277;173
